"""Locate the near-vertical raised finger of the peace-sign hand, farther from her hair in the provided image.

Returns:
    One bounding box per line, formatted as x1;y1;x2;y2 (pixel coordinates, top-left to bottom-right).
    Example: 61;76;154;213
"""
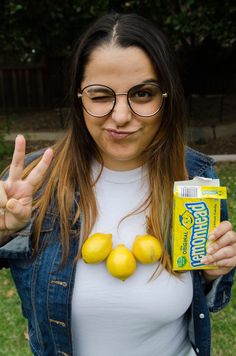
8;135;25;182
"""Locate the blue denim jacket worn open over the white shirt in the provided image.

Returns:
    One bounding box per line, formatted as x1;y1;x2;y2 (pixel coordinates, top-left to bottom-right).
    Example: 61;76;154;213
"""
0;148;234;356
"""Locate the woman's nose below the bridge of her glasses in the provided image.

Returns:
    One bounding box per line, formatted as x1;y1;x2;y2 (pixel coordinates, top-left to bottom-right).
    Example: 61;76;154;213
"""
112;94;132;126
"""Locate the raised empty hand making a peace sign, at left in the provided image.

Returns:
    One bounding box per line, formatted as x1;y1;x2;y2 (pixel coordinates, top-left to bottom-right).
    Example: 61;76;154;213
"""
0;135;53;244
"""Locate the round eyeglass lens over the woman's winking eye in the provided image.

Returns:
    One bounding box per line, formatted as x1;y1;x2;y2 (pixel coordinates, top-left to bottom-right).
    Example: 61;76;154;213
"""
82;85;115;116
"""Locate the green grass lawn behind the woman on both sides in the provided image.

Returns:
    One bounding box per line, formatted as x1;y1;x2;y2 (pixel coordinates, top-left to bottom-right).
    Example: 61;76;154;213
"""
0;154;236;356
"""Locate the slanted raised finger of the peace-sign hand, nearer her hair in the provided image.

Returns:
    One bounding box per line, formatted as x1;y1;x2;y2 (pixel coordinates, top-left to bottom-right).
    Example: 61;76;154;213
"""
25;148;53;187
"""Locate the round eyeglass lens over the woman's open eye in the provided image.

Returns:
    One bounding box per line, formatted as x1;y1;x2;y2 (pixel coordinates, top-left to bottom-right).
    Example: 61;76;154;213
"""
128;84;163;116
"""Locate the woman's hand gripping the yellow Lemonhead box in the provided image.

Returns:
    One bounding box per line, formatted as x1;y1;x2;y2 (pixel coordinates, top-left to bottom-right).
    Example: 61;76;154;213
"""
202;221;236;281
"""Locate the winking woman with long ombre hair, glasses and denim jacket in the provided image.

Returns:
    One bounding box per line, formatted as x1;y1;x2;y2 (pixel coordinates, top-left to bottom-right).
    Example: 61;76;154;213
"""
0;14;236;356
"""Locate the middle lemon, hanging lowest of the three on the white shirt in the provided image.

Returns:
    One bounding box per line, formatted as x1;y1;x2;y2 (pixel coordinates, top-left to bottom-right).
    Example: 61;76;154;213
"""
107;244;136;281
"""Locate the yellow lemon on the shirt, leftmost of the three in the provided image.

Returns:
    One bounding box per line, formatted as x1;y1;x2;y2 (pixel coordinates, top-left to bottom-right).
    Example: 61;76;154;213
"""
82;232;112;263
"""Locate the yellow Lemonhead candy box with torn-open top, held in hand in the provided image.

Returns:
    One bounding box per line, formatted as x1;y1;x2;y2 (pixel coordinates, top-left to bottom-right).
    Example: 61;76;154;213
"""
172;177;227;271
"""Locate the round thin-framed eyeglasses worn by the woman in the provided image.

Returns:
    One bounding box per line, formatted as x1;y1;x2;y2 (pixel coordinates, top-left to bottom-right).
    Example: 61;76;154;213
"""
77;83;168;117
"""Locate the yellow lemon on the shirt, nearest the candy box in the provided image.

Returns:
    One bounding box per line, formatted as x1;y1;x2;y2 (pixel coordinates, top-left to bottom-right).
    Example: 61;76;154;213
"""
132;235;162;264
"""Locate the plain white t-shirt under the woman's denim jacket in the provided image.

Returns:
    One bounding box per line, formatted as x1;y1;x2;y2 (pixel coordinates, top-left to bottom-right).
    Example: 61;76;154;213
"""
72;164;195;356
